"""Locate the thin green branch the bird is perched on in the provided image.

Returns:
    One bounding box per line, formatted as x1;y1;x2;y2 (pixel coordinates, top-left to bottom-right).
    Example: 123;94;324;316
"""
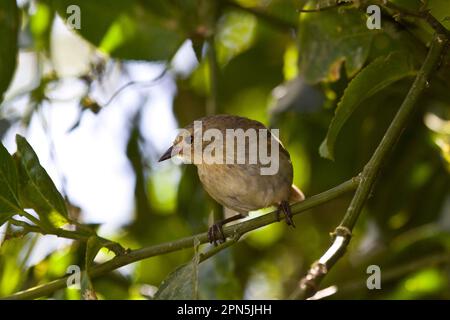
2;177;360;300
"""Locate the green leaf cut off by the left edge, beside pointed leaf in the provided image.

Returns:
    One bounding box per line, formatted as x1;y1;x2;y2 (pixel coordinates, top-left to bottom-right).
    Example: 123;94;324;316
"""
0;143;22;226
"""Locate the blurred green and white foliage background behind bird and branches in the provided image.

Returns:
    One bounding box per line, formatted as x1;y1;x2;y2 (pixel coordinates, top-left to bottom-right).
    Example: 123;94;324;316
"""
0;0;450;299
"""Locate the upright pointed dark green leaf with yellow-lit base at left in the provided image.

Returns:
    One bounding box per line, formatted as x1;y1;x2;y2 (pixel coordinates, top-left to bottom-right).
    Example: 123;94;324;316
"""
16;135;69;227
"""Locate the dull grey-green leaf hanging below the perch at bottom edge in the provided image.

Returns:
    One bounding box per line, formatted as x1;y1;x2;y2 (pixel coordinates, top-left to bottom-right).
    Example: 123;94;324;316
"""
155;240;200;300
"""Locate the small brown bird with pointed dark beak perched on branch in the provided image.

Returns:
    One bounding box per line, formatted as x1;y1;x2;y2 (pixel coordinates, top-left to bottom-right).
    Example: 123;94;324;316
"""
159;115;305;244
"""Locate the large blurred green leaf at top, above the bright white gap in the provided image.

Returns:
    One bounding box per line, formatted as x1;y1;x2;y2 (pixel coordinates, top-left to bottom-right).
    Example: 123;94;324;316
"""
51;0;186;61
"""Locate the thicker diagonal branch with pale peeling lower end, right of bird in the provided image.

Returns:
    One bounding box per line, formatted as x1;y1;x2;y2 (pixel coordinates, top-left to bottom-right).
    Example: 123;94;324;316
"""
291;34;448;299
